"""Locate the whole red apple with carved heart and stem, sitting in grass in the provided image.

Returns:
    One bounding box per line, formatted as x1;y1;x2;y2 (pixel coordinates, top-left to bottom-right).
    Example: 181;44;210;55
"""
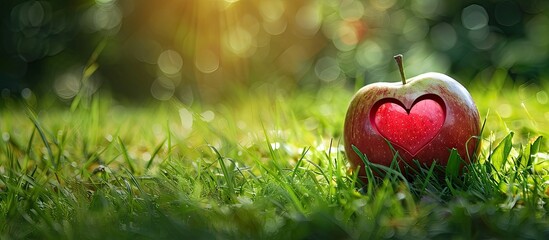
344;55;480;176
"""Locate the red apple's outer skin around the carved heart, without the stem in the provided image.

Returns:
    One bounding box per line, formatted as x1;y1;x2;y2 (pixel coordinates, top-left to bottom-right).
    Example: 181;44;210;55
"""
344;72;480;177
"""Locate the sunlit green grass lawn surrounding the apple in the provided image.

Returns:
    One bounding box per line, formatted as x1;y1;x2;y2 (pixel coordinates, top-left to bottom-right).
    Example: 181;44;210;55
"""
0;75;549;239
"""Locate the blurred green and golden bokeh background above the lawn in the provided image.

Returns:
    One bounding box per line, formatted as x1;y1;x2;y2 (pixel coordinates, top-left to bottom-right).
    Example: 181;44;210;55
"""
0;0;549;104
